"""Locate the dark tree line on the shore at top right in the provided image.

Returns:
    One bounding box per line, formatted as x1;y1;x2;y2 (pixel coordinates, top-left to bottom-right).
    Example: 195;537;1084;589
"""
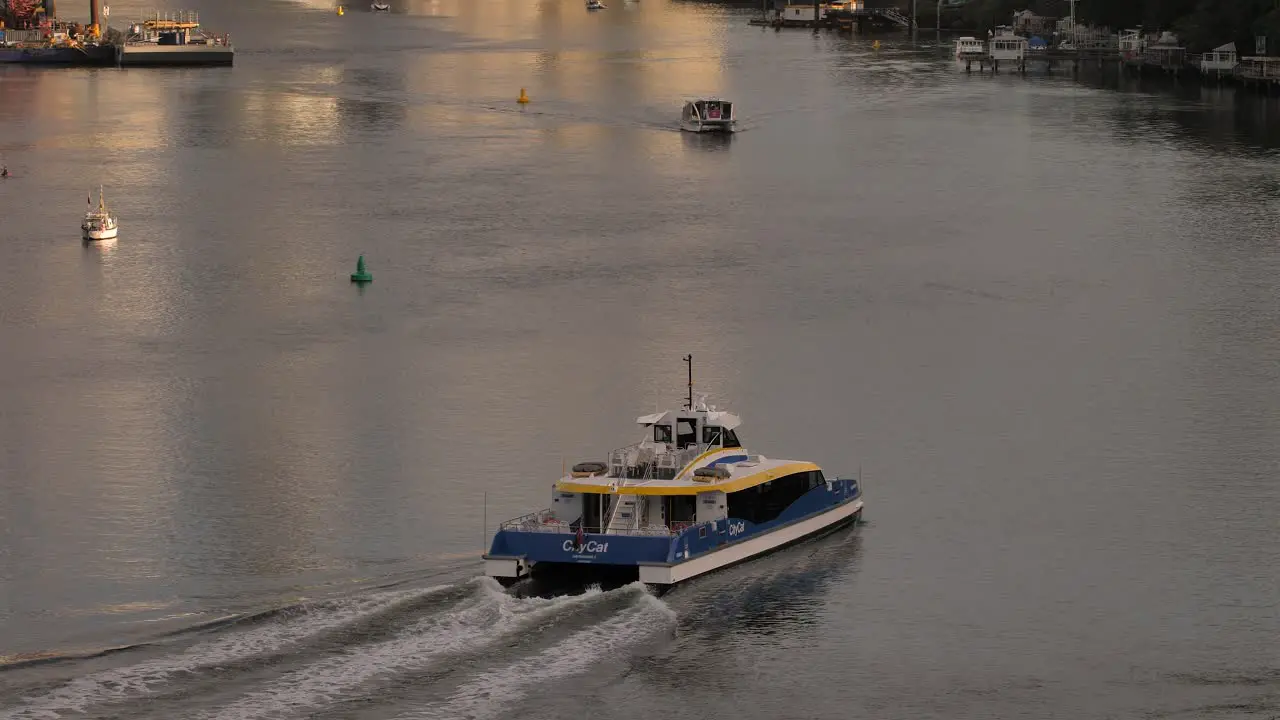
952;0;1280;55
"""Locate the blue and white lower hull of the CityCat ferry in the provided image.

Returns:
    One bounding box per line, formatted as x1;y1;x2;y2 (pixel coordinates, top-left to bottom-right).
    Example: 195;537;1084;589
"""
485;479;861;584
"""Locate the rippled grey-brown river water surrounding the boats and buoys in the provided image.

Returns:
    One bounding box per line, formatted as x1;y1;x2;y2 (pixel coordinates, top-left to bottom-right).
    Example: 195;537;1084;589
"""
0;0;1280;720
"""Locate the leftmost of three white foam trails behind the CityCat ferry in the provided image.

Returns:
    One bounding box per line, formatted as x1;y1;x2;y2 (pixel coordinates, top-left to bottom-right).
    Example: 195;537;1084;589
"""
0;585;449;720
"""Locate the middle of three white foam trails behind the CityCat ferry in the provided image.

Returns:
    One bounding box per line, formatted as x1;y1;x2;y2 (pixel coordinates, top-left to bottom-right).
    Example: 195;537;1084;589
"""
202;578;619;720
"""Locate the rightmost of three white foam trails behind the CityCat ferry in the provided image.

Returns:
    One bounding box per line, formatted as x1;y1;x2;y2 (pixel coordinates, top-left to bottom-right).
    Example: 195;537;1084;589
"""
399;593;676;720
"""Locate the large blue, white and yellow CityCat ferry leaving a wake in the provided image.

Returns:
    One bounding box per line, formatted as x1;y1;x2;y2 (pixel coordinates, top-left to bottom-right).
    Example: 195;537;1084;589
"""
484;357;863;585
